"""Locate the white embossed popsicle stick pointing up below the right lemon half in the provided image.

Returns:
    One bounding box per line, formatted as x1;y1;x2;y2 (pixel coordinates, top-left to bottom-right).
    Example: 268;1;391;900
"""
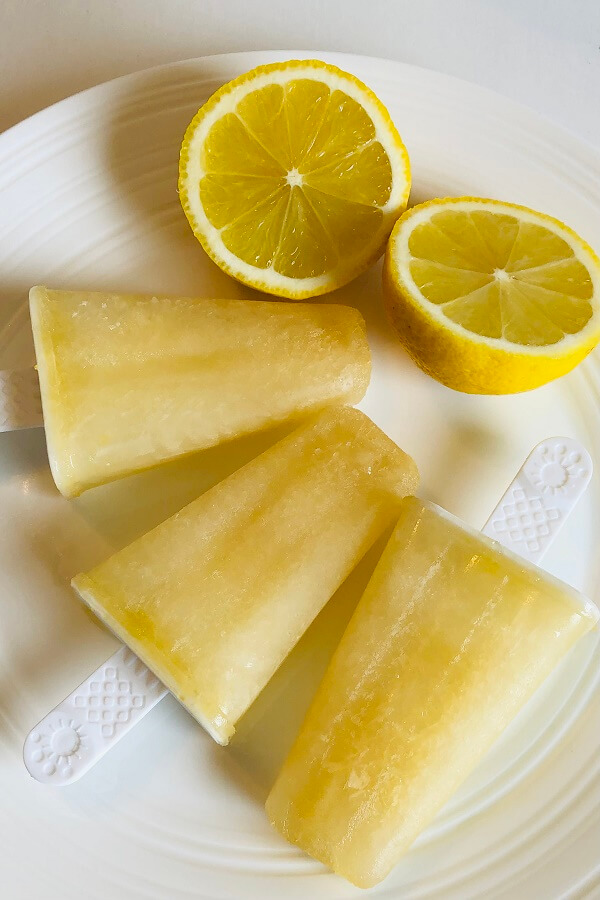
482;437;594;564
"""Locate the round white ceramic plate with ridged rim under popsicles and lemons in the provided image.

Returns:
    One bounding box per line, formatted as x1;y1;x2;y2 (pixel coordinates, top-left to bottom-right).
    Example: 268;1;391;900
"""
0;53;600;900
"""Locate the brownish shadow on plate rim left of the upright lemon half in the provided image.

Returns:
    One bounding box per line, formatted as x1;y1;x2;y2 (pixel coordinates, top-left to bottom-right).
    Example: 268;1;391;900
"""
104;59;255;298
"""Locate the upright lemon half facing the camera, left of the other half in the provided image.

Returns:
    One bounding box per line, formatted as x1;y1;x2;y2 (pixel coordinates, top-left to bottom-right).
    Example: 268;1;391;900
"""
179;60;410;299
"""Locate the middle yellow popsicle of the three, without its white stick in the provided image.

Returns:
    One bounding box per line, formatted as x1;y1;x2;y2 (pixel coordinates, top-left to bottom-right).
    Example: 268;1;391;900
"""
73;406;418;744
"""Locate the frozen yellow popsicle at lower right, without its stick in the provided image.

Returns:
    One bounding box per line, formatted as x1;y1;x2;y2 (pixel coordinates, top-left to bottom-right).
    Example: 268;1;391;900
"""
267;497;597;888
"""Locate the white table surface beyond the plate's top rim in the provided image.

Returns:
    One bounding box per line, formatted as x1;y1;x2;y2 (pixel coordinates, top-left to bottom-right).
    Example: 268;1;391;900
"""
0;0;600;147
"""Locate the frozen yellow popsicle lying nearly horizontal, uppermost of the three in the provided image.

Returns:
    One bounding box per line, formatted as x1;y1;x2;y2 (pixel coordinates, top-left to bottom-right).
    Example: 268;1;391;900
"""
30;287;370;497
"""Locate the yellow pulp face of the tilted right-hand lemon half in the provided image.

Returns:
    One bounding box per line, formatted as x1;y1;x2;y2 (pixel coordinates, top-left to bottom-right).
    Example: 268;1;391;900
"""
408;209;593;346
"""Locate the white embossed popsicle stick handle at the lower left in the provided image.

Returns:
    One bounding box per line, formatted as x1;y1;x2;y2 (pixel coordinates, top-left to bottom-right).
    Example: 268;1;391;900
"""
23;646;168;786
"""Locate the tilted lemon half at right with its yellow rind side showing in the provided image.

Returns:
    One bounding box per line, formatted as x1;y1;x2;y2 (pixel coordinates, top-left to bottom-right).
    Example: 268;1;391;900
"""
384;197;600;394
